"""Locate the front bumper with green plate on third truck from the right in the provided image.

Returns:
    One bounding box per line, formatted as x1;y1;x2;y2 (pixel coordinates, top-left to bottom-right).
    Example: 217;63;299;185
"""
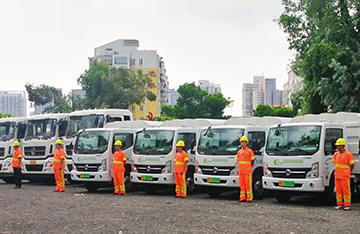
130;172;175;184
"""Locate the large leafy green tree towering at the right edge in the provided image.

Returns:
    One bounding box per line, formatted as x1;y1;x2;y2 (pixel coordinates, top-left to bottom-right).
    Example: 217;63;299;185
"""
279;0;360;113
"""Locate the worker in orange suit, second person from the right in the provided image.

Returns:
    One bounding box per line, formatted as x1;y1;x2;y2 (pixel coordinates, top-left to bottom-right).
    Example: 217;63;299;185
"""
236;136;254;203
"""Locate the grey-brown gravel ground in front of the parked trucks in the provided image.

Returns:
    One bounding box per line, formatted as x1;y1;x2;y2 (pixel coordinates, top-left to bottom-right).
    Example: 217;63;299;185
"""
0;180;360;234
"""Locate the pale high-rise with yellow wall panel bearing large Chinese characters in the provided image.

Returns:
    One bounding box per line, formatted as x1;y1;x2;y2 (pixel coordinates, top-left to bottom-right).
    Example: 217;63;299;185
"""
89;39;169;119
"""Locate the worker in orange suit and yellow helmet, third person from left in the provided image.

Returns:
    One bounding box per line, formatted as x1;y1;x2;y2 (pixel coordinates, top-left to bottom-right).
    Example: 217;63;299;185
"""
113;141;127;195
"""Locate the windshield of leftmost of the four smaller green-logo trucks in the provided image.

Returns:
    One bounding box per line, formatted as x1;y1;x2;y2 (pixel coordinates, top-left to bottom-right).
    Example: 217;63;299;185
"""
74;131;110;154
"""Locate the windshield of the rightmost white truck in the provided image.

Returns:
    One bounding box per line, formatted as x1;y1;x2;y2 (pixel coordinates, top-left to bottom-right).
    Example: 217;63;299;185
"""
266;126;321;156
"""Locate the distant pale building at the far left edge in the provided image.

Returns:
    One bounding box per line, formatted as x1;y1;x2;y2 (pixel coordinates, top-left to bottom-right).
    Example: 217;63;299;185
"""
0;91;27;117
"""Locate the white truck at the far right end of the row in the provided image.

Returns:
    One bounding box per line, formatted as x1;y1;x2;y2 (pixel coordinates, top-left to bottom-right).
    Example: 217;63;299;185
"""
263;112;360;202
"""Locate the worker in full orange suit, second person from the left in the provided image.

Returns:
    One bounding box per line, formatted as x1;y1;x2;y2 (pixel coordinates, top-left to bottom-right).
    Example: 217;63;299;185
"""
53;140;65;192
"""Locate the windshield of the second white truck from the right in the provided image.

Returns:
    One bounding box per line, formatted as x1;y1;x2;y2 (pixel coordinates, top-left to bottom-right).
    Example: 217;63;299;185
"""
198;129;244;155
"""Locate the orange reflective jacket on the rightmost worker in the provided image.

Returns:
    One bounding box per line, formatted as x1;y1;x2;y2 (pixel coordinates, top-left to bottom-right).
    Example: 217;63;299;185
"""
331;150;354;179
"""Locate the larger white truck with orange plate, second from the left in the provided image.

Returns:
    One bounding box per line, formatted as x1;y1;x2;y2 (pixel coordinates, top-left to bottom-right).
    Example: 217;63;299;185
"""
22;113;72;183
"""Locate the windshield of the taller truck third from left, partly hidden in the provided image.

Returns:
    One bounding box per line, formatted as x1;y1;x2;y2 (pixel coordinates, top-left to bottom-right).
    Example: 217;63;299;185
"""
66;115;104;136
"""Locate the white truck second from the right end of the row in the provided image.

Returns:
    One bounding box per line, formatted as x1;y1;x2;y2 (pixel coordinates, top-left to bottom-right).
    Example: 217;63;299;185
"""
194;117;290;198
